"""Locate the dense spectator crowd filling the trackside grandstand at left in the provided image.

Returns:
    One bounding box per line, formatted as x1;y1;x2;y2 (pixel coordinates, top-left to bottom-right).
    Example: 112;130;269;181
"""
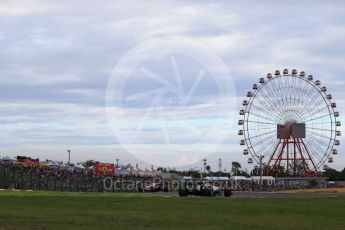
0;156;160;192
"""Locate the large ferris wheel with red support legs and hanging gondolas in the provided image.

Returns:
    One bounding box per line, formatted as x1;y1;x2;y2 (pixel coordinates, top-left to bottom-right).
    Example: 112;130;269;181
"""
238;69;341;176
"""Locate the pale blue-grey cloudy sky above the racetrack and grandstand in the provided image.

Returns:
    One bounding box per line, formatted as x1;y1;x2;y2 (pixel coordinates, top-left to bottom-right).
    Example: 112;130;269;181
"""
0;0;345;169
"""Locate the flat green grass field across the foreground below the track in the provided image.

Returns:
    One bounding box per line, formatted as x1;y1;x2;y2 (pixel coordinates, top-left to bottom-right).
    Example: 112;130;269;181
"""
0;192;345;230
